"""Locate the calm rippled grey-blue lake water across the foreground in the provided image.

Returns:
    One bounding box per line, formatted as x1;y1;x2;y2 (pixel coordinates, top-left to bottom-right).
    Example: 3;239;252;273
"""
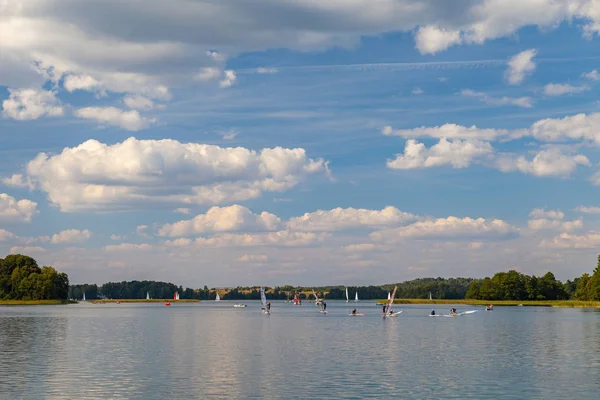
0;301;600;399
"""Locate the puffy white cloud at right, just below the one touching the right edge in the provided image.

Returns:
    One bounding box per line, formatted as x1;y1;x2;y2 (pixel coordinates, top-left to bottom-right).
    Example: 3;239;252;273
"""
496;148;591;176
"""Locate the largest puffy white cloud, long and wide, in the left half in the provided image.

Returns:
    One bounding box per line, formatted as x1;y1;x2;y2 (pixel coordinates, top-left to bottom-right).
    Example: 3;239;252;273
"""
19;138;328;212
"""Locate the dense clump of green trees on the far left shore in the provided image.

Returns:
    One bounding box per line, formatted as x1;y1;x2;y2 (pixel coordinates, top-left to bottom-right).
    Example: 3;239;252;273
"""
0;254;69;300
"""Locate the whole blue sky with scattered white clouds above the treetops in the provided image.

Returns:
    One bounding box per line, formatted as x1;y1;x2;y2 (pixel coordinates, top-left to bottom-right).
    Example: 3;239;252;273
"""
0;0;600;287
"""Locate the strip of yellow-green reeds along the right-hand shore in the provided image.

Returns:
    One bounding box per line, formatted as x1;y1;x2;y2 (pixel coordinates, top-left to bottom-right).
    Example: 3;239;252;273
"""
378;299;600;308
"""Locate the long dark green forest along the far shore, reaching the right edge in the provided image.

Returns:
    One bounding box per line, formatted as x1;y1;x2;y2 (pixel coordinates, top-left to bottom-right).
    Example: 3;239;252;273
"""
69;255;600;301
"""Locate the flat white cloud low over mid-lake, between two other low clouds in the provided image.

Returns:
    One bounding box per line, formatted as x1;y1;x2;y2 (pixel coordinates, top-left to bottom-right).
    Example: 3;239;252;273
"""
287;206;418;232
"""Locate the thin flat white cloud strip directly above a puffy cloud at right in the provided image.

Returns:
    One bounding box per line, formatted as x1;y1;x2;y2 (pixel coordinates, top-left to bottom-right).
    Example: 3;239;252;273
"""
381;124;511;140
